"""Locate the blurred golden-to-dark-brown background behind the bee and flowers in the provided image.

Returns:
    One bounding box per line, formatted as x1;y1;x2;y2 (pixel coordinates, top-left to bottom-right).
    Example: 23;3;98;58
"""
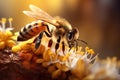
0;0;120;59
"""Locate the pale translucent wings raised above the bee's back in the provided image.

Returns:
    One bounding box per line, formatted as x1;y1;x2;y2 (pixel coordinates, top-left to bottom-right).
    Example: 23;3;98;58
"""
23;5;58;25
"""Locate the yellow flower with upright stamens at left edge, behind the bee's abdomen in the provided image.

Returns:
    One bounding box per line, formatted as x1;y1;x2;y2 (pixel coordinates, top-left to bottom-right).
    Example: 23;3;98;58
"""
0;18;16;50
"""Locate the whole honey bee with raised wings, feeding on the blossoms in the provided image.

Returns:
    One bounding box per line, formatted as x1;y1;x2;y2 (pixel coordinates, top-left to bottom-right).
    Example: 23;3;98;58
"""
17;5;87;52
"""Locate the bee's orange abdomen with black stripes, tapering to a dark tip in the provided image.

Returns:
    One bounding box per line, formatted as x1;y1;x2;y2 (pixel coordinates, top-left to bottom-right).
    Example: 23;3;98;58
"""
17;21;46;41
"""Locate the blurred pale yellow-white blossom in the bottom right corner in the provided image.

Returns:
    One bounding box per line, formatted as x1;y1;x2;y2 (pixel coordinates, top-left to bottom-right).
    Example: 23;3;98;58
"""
86;57;120;80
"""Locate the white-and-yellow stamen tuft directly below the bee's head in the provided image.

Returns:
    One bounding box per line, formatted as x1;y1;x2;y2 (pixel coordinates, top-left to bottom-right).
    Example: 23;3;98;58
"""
49;47;97;69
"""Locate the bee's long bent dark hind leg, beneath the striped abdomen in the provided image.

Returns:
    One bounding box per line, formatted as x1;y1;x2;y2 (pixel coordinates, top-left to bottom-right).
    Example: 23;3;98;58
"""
35;31;52;49
